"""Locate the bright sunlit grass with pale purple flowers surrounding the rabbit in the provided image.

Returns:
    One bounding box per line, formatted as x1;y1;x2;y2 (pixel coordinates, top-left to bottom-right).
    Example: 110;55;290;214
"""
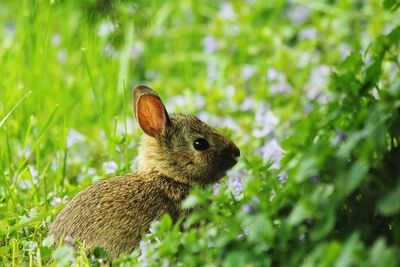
0;0;400;266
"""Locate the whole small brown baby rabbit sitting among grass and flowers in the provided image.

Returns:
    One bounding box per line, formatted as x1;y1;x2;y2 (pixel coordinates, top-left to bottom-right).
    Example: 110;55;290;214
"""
49;85;240;260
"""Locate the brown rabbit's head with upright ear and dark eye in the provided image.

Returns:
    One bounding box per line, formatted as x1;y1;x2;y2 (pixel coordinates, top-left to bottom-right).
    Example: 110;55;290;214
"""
133;85;240;185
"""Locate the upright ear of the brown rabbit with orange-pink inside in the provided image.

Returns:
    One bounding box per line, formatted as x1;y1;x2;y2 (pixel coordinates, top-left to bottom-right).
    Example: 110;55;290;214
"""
133;85;170;137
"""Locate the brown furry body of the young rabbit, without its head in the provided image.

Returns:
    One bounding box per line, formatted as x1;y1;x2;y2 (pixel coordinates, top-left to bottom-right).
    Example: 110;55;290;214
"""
50;172;189;259
